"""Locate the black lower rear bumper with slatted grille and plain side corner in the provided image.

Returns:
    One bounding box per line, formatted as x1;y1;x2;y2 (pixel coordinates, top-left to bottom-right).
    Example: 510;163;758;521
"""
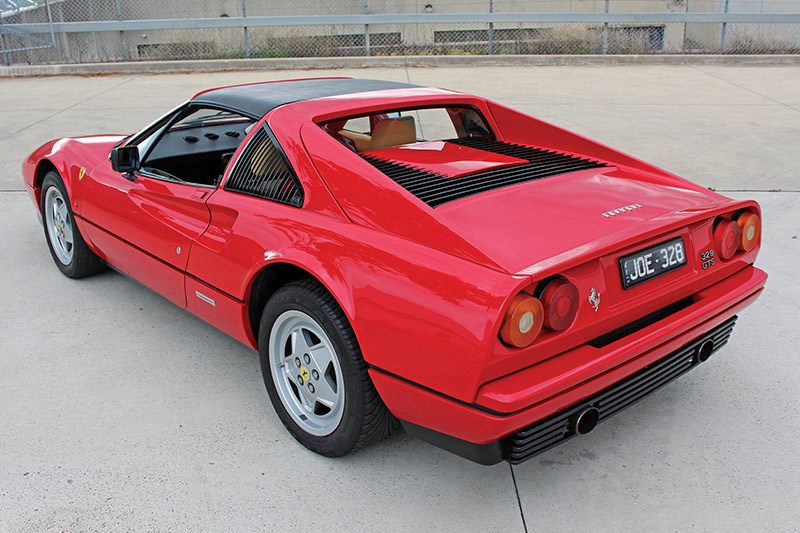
403;316;737;465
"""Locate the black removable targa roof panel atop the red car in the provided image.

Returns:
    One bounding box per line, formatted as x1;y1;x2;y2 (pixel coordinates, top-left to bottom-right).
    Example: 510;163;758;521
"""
192;78;418;118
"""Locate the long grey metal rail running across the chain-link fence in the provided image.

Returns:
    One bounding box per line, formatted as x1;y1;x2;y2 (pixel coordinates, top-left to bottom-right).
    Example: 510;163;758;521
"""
0;13;800;33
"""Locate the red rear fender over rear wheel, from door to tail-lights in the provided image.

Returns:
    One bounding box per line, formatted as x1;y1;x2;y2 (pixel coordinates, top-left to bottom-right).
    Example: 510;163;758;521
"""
188;190;530;401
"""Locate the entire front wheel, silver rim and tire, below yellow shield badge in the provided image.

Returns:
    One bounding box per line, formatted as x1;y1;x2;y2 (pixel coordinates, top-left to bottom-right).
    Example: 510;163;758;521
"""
41;171;105;278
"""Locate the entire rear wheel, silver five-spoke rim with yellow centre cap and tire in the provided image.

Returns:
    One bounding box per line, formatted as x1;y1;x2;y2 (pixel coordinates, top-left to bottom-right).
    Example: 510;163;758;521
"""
259;280;399;457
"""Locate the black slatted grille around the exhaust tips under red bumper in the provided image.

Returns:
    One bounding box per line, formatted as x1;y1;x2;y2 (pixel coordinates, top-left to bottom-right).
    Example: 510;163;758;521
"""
502;316;737;464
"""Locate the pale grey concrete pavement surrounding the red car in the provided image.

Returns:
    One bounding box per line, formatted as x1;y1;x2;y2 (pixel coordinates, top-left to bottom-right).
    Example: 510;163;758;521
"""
0;65;800;533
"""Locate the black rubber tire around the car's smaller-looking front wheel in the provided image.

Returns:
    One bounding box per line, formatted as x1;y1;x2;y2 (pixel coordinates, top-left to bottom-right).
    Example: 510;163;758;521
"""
39;170;106;279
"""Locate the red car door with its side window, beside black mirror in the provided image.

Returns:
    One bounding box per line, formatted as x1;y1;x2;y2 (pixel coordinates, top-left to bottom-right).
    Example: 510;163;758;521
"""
82;104;252;307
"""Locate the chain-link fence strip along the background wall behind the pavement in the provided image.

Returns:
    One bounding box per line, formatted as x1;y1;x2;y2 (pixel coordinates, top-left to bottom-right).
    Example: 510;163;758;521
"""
0;0;800;64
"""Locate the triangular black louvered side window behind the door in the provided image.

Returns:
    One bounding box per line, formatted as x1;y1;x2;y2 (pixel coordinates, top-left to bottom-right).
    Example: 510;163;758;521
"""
225;128;303;207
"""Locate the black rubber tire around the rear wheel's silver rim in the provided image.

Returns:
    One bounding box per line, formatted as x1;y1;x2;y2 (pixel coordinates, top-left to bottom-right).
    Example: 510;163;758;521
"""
258;279;400;457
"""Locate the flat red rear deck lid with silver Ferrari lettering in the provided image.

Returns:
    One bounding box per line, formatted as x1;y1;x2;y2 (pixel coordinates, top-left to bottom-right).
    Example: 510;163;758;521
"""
436;169;721;273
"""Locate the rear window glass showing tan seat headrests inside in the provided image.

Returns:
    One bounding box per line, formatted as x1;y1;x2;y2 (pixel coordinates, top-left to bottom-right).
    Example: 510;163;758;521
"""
321;106;495;153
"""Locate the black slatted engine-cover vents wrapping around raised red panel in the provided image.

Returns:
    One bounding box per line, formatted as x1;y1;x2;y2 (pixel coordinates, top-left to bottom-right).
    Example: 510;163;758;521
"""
362;139;607;207
